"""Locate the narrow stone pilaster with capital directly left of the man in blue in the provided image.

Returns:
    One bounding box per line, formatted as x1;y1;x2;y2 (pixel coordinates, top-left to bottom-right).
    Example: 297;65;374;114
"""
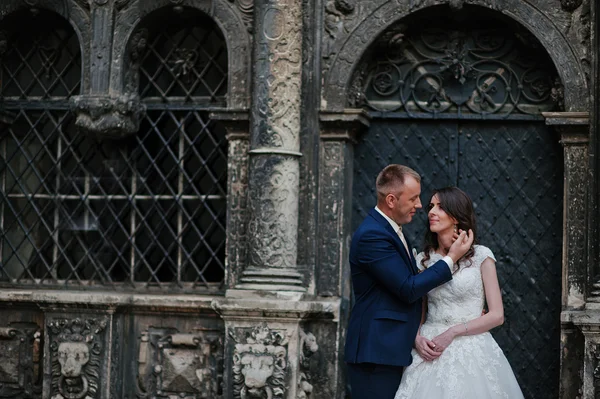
316;109;370;298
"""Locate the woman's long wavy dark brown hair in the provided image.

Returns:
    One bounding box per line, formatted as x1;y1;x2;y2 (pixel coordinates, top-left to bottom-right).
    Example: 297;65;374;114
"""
421;187;477;273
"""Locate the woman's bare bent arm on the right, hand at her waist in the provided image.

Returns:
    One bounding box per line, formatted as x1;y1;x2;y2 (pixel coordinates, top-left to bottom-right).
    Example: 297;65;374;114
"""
433;258;504;351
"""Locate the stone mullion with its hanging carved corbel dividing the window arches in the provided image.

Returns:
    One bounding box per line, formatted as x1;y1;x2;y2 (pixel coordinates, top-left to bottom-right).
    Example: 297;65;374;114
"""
71;0;146;138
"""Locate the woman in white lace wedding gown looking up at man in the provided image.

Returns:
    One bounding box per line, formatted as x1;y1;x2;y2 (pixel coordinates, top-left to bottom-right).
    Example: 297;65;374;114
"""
395;187;523;399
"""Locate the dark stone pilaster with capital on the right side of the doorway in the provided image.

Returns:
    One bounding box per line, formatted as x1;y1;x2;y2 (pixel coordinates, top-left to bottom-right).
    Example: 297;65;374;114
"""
544;112;600;399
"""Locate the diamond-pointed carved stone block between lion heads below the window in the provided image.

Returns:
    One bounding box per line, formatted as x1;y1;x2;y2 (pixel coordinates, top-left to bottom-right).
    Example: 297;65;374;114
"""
137;328;223;399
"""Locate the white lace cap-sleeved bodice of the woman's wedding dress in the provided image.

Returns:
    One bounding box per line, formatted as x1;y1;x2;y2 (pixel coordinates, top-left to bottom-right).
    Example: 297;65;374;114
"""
416;245;496;325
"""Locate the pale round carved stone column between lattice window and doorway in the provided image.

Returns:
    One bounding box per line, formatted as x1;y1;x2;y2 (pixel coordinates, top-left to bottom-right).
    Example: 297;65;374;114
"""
236;0;305;292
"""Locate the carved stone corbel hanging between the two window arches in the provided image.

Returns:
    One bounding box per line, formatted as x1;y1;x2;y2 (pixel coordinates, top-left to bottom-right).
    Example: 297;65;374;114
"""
71;94;145;138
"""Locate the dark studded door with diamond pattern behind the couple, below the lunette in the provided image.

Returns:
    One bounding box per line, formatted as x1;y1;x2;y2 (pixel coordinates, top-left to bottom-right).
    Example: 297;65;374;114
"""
353;119;563;399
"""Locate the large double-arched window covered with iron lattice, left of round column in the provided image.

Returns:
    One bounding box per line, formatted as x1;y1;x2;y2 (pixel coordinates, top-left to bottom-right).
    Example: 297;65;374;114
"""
0;9;227;291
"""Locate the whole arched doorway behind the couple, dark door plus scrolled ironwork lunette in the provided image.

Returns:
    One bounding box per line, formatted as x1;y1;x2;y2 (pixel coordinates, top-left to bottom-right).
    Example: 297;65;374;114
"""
350;7;563;398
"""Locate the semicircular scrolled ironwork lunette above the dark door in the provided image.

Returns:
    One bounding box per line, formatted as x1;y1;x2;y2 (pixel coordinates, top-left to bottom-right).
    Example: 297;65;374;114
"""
353;9;560;119
